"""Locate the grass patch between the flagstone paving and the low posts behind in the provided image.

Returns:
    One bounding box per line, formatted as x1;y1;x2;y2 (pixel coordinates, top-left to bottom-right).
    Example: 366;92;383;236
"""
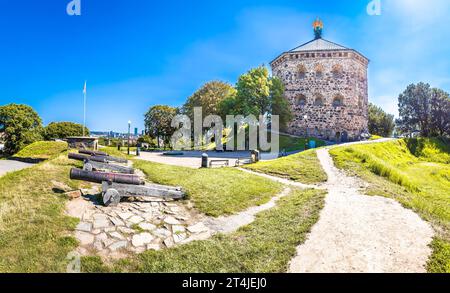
134;160;282;217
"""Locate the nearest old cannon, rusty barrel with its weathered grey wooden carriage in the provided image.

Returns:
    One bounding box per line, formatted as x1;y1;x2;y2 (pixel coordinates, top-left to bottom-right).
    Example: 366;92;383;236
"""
70;169;185;206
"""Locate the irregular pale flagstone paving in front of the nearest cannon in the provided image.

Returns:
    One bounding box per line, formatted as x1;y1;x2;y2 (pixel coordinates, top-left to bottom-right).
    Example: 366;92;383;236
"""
67;188;214;258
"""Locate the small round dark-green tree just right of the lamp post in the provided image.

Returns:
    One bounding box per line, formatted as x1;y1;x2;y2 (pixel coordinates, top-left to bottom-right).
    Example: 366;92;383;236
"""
145;105;177;148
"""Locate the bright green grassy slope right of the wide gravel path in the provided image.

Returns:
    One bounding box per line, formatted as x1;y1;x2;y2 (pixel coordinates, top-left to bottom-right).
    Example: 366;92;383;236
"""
330;139;450;273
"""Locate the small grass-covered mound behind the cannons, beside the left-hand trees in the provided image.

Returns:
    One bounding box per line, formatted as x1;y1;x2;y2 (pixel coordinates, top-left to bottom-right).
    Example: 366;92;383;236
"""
13;141;68;160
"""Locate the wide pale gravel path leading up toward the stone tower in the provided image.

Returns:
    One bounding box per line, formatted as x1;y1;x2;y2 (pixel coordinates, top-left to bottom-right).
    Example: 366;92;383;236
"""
290;149;434;273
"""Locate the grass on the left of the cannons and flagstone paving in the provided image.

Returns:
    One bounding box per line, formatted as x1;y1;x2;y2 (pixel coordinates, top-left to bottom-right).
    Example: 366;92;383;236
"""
0;151;85;272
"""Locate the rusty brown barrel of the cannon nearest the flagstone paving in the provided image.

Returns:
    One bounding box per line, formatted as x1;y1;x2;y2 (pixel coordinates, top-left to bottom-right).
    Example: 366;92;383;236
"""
70;168;145;185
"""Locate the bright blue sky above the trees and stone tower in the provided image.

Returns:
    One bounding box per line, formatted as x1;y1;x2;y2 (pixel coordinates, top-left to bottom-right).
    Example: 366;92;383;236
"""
0;0;450;131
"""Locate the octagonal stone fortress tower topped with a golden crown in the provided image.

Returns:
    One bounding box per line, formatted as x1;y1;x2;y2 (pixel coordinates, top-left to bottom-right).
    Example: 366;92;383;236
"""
270;19;369;142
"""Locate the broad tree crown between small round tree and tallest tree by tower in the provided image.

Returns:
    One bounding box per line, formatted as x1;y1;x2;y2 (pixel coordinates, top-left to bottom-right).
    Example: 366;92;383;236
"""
182;81;236;119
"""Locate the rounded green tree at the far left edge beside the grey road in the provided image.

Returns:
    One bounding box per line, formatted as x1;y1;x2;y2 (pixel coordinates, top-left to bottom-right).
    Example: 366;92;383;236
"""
0;104;42;155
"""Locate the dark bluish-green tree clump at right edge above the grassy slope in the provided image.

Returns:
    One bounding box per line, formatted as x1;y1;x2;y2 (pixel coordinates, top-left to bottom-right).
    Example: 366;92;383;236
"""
397;82;450;137
